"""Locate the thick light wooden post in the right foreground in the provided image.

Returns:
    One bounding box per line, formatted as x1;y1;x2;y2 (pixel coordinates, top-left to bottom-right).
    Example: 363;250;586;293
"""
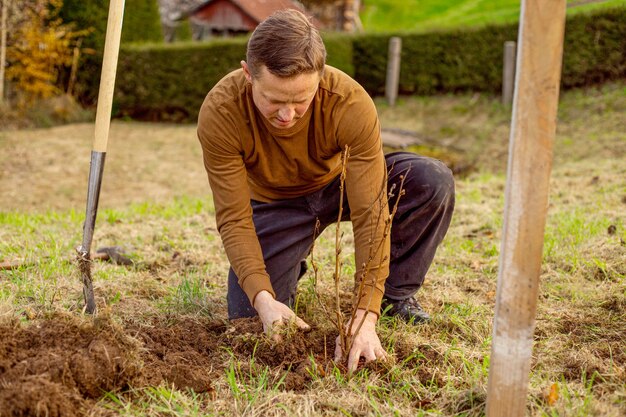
486;0;566;417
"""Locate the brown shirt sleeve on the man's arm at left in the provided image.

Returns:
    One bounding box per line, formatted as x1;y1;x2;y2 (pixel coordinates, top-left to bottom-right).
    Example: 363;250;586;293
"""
198;98;276;305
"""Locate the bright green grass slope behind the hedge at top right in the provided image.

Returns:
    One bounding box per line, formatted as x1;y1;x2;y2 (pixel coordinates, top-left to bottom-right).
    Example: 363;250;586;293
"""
361;0;626;32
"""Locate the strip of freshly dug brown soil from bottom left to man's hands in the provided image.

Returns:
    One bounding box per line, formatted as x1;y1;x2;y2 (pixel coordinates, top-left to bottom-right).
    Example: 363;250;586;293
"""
0;314;342;417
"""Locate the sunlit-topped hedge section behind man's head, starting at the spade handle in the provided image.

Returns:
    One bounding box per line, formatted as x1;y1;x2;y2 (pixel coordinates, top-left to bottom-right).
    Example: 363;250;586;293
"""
114;35;354;121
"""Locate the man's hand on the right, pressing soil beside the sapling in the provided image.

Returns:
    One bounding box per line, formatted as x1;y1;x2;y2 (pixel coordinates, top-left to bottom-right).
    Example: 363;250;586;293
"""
335;309;387;372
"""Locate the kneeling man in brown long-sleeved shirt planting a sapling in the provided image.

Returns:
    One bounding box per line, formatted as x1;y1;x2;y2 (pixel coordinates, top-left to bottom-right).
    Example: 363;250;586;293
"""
198;10;454;370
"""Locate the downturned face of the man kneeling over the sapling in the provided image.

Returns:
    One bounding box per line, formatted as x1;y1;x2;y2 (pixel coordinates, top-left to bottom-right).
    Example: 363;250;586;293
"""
241;61;320;129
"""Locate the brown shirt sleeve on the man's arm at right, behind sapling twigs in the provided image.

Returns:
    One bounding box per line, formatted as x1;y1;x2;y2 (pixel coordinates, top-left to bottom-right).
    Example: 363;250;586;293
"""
337;85;390;314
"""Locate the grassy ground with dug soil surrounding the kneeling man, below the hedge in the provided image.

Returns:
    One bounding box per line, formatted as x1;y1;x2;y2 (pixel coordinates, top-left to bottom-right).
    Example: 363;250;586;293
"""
0;83;626;417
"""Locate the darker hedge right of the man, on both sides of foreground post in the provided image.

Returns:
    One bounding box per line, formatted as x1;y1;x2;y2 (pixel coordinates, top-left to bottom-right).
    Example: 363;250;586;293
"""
354;8;626;95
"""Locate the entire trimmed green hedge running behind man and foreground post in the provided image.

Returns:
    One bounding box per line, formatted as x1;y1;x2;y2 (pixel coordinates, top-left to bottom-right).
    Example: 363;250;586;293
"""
109;8;626;121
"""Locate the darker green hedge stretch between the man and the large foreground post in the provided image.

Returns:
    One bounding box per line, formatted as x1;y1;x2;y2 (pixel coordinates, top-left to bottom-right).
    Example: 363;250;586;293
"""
354;26;517;95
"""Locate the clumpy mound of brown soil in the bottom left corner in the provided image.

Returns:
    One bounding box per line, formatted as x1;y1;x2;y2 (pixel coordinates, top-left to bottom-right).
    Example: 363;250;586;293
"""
0;316;140;416
